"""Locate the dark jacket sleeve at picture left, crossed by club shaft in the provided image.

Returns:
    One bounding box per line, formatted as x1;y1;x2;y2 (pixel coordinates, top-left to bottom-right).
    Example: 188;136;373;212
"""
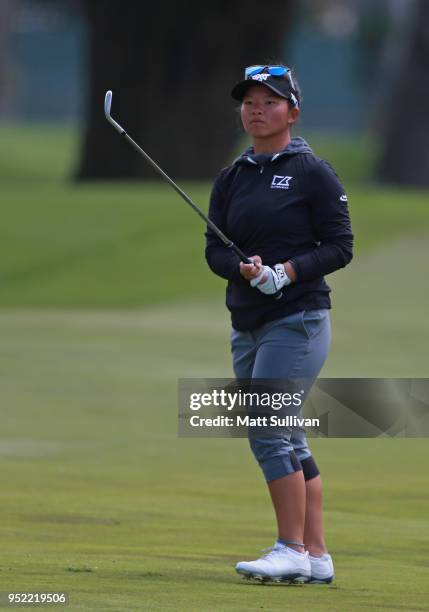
205;171;242;281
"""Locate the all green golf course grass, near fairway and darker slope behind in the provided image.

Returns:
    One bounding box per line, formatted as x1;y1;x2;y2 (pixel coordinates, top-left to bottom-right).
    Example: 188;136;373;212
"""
0;126;429;612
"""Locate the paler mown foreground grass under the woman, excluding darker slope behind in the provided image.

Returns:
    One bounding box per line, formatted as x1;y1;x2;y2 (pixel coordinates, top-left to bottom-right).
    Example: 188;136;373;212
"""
0;236;429;612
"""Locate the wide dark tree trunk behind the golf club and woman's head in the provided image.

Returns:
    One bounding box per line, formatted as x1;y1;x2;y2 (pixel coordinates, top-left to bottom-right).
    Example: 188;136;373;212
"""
77;0;295;179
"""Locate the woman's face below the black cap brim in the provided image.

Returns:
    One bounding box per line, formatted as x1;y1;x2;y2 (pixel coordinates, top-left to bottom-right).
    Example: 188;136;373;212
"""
241;84;299;139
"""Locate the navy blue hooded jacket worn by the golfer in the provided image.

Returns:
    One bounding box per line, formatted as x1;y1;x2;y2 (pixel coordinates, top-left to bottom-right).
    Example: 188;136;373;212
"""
206;138;353;331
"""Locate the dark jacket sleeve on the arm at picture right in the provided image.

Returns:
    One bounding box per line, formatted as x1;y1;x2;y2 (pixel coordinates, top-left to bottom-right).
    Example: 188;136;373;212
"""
290;160;353;282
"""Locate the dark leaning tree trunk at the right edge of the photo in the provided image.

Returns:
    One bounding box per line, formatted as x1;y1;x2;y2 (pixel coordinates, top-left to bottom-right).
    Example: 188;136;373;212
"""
377;0;429;187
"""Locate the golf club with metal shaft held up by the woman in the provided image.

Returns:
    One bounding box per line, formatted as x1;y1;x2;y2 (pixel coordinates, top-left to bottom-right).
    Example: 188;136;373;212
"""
104;90;282;299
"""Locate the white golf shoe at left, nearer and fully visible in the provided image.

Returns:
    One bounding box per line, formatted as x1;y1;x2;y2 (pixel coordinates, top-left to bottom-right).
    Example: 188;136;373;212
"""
235;542;311;582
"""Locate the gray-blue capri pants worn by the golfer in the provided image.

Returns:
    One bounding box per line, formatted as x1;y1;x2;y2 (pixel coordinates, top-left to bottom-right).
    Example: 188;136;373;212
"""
231;309;331;482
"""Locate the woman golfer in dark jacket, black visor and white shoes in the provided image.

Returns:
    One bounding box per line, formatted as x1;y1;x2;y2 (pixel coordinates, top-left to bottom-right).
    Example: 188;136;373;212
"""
206;65;353;583
